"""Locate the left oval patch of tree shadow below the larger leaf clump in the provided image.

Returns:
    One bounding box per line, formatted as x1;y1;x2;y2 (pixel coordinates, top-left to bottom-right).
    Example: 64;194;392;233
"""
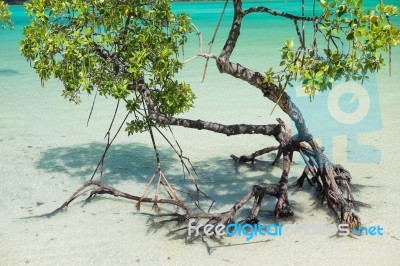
36;142;178;185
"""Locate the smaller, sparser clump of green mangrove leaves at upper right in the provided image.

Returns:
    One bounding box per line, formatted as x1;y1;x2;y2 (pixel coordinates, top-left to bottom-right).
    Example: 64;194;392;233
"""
265;0;400;96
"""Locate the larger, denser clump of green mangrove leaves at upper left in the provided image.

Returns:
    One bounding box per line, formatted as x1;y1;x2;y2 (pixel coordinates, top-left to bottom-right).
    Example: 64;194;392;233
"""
20;0;194;133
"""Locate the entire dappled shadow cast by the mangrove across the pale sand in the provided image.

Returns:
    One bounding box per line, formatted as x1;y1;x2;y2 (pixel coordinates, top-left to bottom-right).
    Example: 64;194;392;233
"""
36;142;306;216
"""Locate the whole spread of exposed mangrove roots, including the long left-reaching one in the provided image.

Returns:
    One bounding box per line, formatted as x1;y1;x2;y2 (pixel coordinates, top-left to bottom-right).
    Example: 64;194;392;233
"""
40;117;361;236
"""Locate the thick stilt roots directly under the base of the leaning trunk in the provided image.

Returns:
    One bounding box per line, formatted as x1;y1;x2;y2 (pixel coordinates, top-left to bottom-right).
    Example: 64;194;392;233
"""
231;120;361;228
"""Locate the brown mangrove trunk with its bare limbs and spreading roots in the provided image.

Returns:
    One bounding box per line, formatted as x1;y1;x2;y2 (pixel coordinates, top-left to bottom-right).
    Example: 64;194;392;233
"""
52;0;361;233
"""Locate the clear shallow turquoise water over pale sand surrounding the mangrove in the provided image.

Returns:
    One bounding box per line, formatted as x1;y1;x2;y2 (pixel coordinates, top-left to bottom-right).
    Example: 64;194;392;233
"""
0;0;400;265
